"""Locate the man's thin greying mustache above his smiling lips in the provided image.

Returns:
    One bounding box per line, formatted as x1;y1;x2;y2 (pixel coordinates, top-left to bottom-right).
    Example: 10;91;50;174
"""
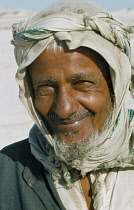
48;110;95;124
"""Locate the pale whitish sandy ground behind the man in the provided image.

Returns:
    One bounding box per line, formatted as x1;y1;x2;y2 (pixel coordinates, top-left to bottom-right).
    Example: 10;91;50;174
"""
0;9;134;148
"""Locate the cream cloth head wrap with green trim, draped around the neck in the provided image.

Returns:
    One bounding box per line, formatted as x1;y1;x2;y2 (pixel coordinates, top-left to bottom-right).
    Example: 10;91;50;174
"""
12;0;134;186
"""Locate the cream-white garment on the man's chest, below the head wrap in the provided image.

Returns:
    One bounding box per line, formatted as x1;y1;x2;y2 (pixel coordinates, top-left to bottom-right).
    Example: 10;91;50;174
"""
55;168;134;210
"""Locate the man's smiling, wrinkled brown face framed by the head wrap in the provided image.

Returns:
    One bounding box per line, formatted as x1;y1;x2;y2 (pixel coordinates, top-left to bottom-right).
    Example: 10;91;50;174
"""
29;47;111;143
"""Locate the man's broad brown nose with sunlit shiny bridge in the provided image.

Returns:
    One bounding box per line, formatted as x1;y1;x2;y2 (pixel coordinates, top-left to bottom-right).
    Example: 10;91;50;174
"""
52;88;79;119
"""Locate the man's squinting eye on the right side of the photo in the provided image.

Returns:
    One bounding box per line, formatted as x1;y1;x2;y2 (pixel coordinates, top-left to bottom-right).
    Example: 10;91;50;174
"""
73;80;94;92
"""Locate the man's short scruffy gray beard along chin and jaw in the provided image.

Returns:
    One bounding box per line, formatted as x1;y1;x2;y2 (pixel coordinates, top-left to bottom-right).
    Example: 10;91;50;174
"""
53;107;113;169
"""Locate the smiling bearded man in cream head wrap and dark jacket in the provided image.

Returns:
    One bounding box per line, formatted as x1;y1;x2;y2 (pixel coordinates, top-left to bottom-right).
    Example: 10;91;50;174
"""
0;0;134;210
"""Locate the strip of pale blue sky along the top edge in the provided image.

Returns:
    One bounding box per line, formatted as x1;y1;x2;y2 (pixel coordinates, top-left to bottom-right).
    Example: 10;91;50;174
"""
0;0;134;11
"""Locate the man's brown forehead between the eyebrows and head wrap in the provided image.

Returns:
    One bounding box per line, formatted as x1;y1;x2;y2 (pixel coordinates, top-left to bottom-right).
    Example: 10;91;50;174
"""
30;46;108;84
